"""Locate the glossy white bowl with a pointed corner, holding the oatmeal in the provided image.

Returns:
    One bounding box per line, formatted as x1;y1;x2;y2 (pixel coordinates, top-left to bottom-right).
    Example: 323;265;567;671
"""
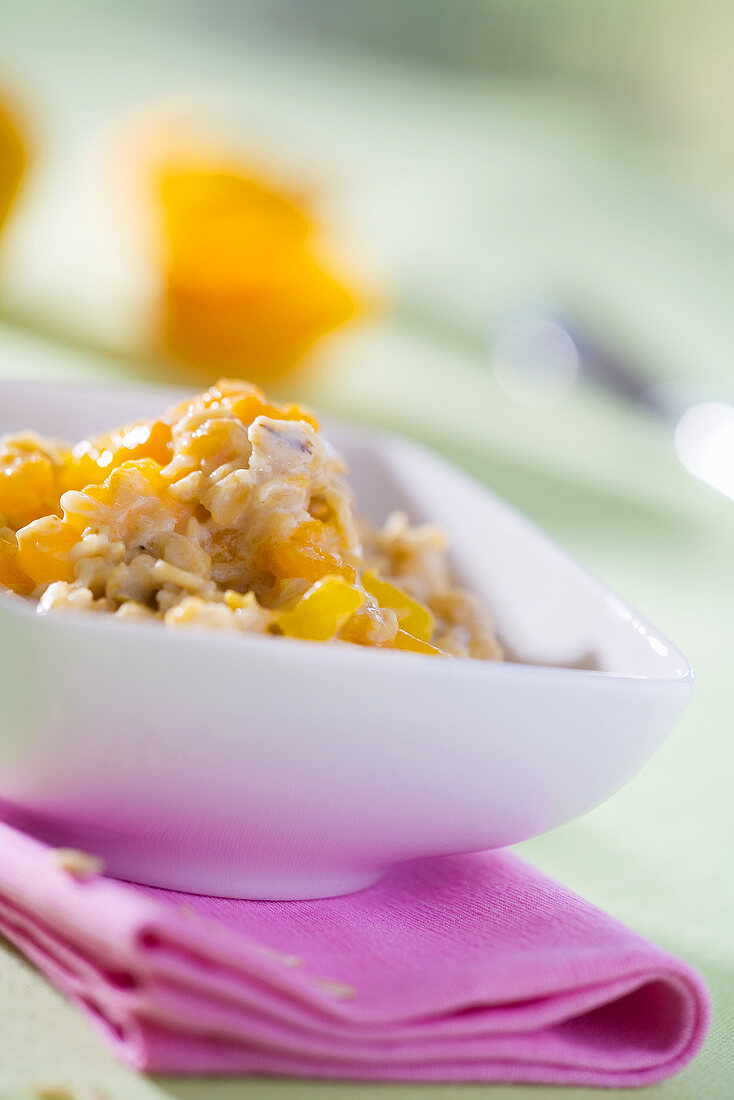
0;383;693;899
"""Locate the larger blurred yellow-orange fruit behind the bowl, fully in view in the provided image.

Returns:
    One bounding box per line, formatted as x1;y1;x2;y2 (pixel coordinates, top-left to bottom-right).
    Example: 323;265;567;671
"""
155;157;358;381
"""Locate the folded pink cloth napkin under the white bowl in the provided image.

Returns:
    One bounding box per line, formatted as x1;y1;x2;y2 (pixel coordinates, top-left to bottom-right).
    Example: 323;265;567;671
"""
0;825;710;1087
